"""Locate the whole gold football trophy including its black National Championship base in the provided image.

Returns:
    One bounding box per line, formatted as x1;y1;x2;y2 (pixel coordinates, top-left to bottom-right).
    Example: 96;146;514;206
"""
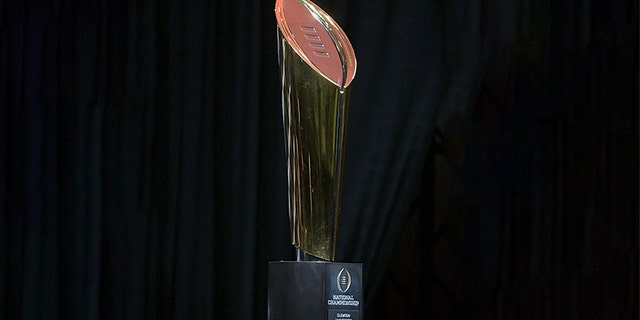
268;0;363;320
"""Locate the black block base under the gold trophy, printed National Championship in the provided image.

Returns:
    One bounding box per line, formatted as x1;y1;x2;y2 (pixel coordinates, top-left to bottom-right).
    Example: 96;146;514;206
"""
268;261;363;320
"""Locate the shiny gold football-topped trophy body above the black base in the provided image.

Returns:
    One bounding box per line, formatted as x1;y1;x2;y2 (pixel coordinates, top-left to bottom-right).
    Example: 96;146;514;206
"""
275;0;356;261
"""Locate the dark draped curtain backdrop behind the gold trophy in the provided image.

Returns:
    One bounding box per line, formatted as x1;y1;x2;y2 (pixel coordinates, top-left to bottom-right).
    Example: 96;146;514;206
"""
0;0;638;319
